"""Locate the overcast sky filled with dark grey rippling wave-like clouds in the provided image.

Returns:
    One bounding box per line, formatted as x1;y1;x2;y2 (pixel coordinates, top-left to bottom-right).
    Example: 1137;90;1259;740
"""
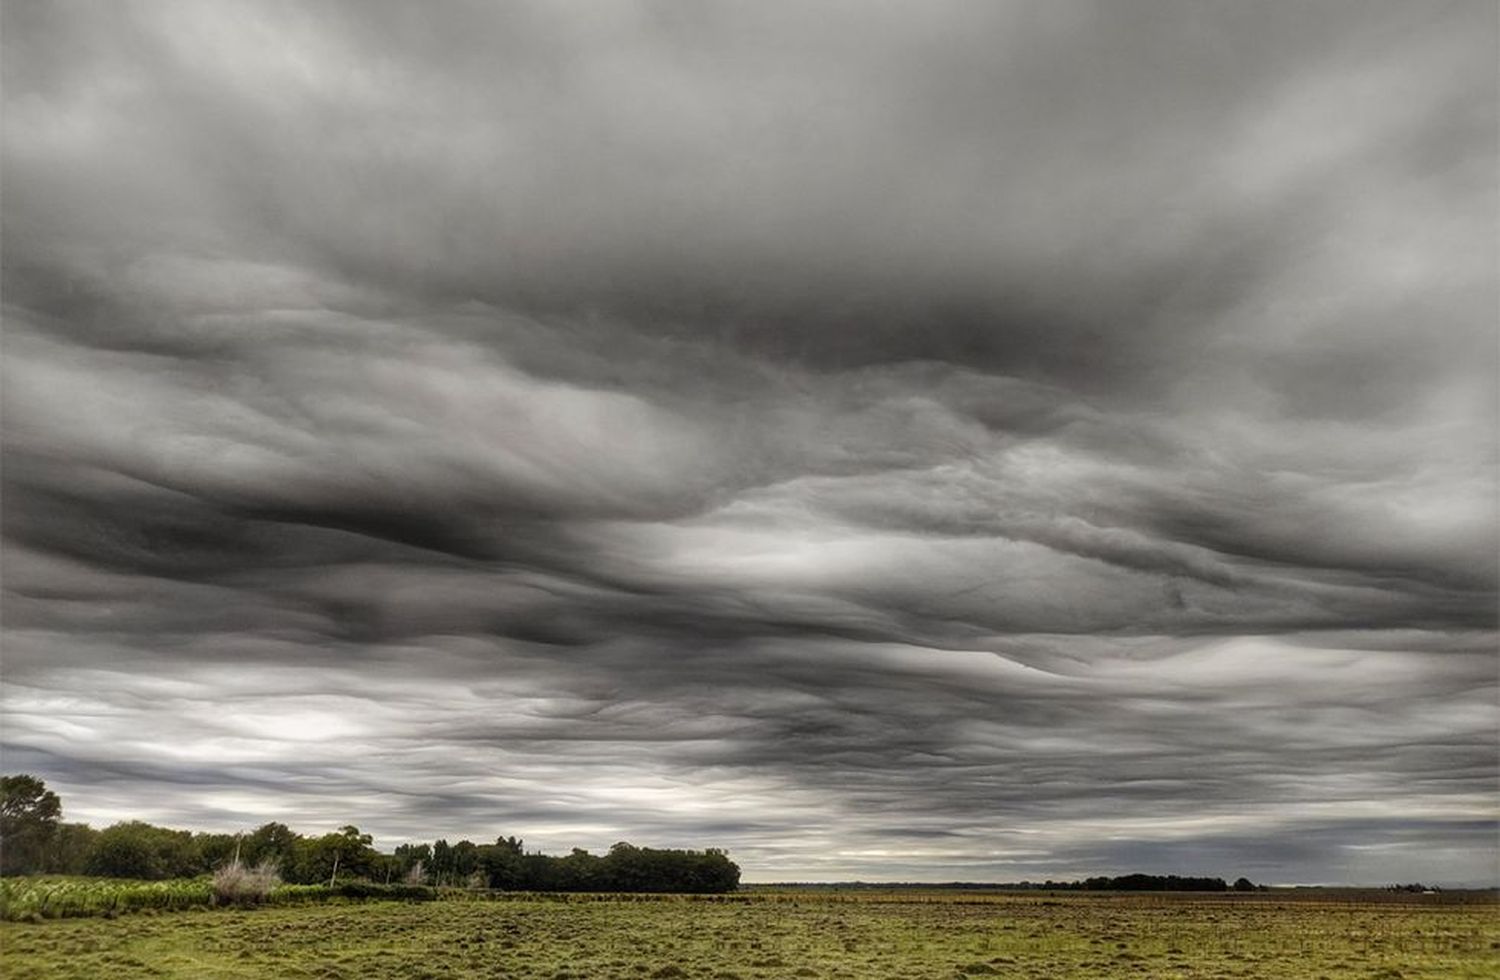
0;0;1500;884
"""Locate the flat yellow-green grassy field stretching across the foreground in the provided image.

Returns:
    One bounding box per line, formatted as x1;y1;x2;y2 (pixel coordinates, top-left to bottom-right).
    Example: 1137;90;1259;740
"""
0;891;1500;980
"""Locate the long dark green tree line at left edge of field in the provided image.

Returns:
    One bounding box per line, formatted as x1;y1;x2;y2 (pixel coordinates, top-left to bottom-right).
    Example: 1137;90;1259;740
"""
0;776;740;893
